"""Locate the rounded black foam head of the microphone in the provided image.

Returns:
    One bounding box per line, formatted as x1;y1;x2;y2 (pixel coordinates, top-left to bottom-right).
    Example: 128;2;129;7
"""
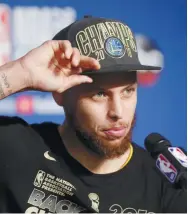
144;133;171;153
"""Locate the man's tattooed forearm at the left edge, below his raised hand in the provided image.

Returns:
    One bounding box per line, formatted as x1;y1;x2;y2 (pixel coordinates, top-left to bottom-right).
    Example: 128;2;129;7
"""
0;60;28;100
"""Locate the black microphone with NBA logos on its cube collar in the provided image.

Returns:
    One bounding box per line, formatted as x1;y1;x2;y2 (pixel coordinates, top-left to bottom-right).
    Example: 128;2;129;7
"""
144;133;187;189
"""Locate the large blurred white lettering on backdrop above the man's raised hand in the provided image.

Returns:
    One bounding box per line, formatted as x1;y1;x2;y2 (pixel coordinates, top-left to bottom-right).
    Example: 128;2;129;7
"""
12;6;76;59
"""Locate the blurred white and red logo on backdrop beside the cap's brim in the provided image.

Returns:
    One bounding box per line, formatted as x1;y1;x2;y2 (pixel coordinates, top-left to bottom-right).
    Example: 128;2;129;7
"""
135;34;164;86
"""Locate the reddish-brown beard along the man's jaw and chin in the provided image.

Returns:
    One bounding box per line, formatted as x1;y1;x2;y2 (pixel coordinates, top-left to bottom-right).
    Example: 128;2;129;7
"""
67;112;136;159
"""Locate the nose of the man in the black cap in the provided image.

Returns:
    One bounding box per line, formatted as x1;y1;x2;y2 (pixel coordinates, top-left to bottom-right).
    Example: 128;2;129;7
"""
108;97;123;121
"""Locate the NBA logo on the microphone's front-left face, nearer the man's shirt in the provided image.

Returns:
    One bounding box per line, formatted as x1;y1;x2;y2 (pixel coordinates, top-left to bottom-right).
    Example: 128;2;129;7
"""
156;154;177;183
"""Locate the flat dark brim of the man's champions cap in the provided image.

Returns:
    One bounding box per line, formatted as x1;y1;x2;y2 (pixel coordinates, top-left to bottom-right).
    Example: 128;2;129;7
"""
84;64;162;74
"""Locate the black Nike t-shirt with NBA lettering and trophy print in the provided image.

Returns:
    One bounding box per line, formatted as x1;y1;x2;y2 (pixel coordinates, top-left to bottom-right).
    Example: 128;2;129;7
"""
0;117;187;213
